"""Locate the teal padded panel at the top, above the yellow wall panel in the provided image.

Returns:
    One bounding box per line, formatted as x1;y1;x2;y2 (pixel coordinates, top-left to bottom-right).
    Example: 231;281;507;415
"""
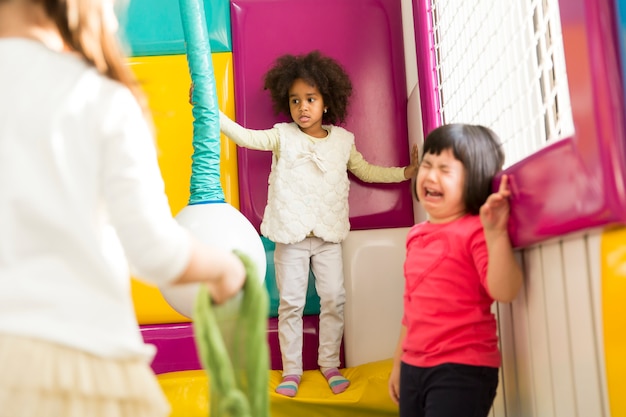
118;0;232;57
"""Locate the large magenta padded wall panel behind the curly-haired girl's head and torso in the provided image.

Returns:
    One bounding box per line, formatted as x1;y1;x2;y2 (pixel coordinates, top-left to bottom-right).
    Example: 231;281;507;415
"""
231;0;413;229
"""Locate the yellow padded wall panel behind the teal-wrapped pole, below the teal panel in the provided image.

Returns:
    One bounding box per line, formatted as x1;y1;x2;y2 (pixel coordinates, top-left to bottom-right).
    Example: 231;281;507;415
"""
129;52;239;324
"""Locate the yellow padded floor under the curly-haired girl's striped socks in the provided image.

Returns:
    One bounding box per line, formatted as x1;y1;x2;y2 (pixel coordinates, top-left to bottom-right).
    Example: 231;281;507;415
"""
158;359;398;417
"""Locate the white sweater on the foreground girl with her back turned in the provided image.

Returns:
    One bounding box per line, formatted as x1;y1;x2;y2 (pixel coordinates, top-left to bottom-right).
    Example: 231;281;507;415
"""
0;38;190;358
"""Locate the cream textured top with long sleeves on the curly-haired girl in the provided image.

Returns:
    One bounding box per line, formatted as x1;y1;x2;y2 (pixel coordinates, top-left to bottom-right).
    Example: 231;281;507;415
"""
220;114;405;244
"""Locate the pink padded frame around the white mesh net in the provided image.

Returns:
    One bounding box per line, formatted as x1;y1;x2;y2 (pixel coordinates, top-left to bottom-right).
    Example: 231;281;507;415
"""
413;0;626;247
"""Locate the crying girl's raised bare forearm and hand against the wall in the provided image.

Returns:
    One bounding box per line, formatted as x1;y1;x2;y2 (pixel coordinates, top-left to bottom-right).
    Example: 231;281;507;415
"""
480;175;523;302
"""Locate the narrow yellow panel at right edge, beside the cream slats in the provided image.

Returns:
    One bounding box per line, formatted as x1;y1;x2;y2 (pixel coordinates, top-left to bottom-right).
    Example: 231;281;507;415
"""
601;228;626;416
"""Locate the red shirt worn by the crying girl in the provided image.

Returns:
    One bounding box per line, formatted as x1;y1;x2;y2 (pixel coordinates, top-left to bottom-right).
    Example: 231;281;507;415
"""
402;215;500;367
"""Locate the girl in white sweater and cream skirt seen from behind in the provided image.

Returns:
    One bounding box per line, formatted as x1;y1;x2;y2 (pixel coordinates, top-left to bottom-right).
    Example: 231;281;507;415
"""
0;0;245;417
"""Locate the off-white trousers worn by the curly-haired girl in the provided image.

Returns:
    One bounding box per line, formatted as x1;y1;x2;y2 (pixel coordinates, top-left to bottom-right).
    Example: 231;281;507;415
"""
274;237;346;375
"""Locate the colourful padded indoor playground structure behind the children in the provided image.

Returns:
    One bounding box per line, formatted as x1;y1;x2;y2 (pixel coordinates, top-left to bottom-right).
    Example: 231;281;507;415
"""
111;0;626;417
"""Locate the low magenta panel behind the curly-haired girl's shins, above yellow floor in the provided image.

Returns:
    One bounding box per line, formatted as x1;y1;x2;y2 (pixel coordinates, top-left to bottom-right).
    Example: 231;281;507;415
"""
141;315;338;374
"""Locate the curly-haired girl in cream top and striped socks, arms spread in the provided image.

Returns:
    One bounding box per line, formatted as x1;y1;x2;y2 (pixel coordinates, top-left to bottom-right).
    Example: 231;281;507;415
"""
220;51;417;397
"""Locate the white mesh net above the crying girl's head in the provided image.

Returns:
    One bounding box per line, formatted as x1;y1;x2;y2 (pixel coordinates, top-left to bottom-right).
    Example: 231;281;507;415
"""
430;0;573;166
